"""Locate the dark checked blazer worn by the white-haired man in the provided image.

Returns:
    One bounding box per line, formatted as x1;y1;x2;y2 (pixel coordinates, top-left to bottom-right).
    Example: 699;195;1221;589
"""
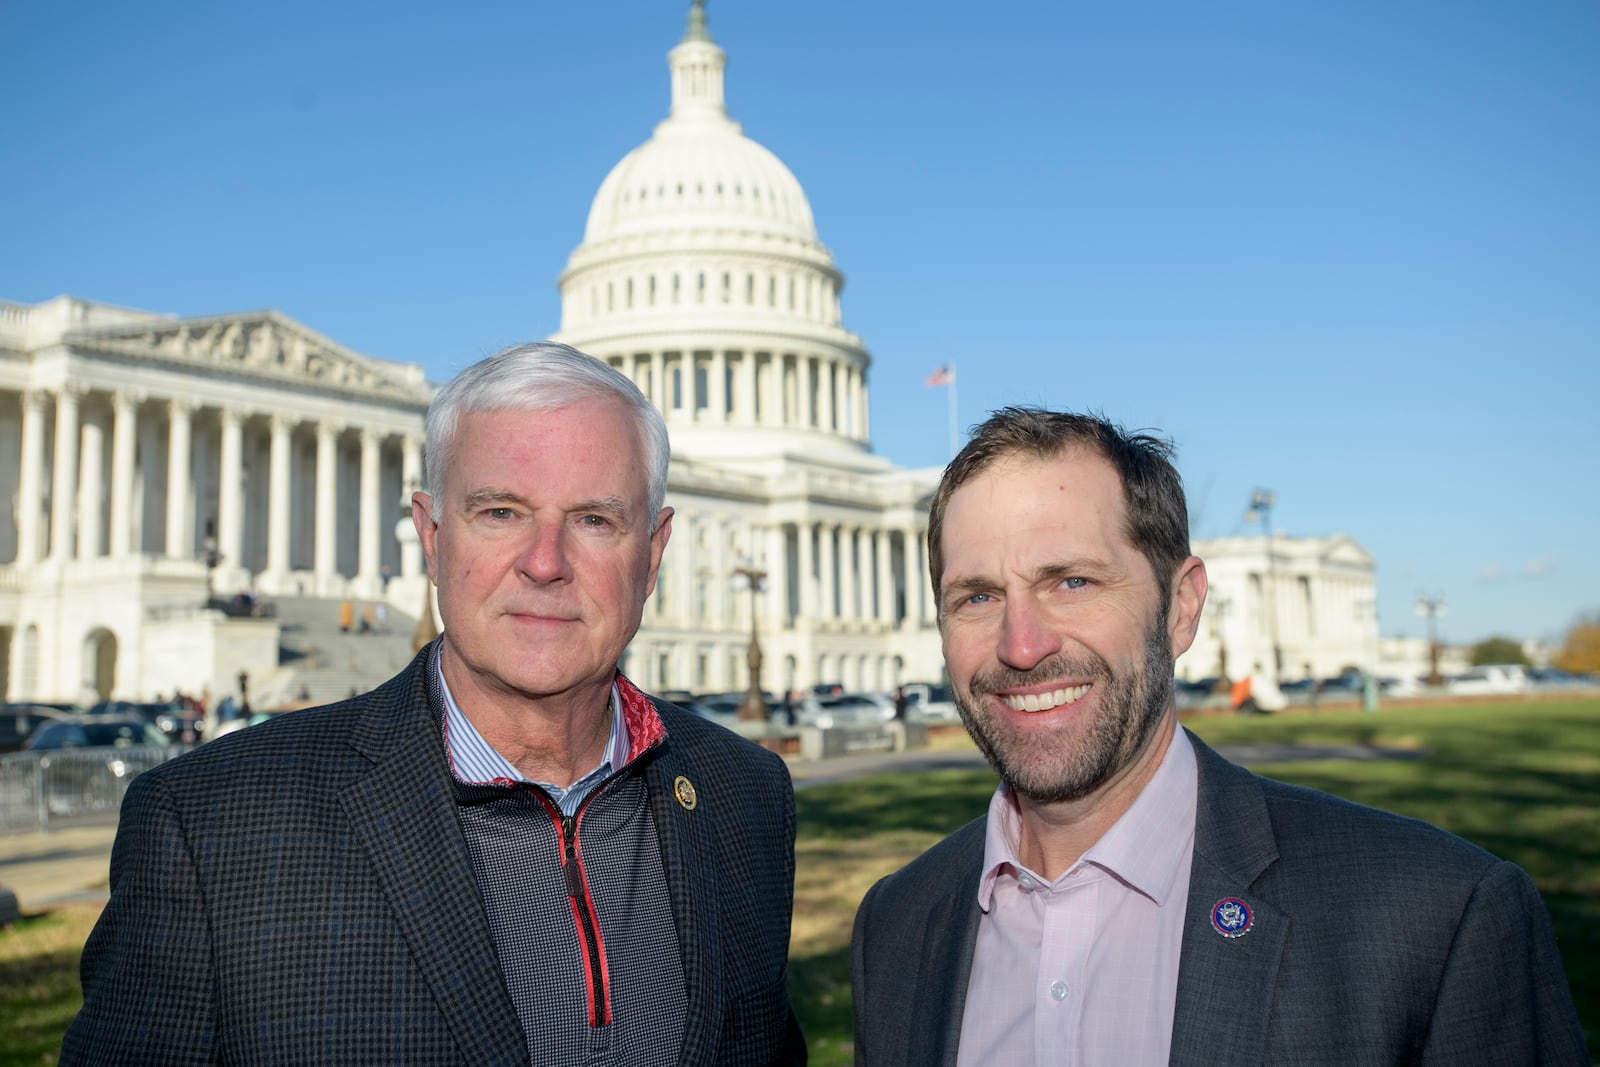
61;649;805;1067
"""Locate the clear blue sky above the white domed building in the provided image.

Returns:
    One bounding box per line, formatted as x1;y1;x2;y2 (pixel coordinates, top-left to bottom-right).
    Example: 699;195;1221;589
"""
0;0;1600;641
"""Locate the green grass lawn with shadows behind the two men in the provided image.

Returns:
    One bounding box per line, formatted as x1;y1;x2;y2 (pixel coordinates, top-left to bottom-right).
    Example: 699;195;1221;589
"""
0;701;1600;1067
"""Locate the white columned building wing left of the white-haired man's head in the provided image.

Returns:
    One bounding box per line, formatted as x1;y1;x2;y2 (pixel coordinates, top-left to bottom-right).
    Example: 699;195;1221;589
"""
0;298;432;701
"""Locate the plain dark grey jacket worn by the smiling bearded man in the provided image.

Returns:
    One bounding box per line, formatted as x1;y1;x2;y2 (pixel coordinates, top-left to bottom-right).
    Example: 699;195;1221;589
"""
851;736;1589;1067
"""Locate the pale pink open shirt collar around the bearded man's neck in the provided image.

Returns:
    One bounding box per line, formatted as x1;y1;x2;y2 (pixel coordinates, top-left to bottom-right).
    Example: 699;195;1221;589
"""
978;726;1198;912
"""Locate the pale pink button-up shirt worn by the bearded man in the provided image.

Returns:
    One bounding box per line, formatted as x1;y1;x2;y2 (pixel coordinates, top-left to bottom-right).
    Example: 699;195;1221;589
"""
957;729;1197;1067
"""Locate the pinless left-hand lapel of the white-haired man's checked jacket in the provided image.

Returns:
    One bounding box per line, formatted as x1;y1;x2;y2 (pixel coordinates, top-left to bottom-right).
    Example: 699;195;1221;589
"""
339;656;528;1064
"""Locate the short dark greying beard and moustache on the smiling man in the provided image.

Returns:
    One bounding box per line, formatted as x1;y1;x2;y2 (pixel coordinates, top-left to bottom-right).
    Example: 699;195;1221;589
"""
952;605;1173;805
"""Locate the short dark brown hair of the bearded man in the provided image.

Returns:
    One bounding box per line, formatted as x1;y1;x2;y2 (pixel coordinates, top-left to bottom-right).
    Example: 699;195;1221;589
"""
928;406;1189;619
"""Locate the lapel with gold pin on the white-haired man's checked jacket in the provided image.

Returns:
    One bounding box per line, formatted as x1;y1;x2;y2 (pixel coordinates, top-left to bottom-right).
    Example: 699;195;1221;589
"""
645;737;723;1067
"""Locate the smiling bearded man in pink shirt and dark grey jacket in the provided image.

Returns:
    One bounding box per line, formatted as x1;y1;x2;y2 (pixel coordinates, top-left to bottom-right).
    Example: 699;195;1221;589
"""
851;408;1589;1067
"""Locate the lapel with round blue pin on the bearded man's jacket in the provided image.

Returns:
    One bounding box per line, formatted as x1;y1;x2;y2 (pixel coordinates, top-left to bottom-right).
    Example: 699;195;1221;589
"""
1170;734;1290;1065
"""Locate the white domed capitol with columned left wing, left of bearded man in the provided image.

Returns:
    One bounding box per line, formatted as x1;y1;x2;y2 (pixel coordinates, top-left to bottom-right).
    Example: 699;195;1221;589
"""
0;0;942;713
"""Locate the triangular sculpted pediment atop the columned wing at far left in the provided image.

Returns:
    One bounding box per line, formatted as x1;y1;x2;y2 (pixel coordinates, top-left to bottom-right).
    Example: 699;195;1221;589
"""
62;312;432;406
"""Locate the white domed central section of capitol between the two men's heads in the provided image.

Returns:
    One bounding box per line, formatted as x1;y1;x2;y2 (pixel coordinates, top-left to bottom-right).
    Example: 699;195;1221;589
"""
552;0;941;691
